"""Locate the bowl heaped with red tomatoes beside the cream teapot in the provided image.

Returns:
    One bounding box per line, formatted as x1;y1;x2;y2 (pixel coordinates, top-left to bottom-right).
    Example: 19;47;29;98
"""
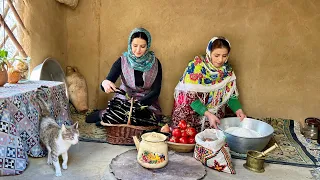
168;120;197;152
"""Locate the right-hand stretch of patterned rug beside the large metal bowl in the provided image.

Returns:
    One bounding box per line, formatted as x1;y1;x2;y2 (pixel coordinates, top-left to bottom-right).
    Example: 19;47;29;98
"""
231;118;320;167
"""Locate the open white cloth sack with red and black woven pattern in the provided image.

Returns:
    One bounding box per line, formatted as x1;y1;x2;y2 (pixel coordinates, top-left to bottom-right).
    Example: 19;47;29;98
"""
193;129;236;174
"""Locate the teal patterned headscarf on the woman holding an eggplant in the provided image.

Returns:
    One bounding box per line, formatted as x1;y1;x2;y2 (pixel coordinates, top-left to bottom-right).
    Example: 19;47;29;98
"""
123;28;155;72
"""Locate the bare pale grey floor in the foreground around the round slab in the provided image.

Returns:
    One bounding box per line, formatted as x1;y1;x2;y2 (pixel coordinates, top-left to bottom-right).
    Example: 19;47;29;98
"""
4;142;312;180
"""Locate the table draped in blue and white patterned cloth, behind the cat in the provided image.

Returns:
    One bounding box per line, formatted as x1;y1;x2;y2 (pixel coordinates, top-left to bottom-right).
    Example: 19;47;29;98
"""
0;81;71;176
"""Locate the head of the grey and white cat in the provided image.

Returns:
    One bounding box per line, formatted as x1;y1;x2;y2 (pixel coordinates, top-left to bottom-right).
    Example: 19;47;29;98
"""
61;122;79;145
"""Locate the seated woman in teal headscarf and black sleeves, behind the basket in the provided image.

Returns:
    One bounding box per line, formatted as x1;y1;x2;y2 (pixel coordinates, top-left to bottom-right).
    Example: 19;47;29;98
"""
86;28;162;125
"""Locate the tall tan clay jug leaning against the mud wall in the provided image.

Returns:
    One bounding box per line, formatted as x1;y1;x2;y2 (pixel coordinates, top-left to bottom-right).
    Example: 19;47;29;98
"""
66;66;88;112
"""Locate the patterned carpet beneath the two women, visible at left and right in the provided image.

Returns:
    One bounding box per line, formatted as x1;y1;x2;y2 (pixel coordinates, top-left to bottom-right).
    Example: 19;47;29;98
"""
70;105;320;167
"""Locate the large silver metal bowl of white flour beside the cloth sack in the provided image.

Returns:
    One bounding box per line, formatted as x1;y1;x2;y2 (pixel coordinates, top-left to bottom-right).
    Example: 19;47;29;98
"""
218;117;274;154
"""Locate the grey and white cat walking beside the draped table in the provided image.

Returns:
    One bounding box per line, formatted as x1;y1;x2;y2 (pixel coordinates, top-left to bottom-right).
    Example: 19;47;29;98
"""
37;91;79;176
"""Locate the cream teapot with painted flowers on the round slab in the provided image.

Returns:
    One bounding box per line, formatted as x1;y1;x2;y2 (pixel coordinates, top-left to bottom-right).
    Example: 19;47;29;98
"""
133;132;169;169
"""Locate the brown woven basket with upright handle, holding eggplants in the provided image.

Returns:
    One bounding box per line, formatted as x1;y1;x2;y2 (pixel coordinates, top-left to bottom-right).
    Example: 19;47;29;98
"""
101;98;159;145
